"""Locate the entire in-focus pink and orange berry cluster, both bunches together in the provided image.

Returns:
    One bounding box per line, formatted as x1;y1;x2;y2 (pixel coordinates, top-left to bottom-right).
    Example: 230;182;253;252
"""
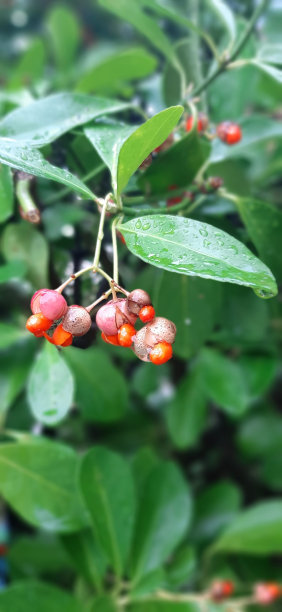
26;289;176;365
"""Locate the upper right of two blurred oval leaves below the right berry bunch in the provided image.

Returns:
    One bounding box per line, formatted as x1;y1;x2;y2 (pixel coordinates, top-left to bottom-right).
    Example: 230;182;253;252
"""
201;349;249;417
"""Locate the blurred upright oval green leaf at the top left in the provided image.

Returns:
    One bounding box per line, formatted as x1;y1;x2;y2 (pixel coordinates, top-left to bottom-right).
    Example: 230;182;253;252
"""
46;4;80;71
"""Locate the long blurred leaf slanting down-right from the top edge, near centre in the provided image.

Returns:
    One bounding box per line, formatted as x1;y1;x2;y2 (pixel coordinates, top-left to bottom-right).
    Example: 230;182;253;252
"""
99;0;174;58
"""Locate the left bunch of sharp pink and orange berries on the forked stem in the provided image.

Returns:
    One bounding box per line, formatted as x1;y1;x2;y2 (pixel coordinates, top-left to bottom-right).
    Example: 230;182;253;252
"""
26;289;91;347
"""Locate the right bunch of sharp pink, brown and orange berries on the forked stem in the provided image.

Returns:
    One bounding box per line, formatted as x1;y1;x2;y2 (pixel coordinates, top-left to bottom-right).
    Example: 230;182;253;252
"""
96;289;176;365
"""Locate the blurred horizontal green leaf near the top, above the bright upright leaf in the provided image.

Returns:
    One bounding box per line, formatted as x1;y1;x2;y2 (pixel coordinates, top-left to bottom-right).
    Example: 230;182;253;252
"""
76;47;157;93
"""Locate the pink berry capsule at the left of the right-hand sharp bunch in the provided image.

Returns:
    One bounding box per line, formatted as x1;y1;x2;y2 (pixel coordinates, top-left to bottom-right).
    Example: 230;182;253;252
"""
96;298;137;336
